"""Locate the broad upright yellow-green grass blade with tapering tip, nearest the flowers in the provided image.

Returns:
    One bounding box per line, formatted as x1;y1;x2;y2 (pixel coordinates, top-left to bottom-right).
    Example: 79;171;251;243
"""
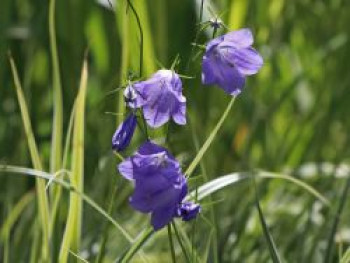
59;59;88;263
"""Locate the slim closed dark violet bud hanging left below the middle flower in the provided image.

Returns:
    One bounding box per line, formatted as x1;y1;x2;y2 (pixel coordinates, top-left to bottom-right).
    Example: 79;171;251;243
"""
112;113;137;152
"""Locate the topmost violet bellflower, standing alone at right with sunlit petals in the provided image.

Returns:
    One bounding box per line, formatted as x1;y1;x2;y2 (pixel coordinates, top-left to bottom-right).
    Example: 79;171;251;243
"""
202;29;263;96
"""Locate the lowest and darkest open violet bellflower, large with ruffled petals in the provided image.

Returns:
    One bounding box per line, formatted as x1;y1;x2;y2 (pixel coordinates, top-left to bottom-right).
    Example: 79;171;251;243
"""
118;142;187;230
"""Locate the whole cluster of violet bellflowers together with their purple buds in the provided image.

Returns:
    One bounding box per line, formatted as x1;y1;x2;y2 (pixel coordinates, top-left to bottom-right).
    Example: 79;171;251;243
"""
112;26;263;230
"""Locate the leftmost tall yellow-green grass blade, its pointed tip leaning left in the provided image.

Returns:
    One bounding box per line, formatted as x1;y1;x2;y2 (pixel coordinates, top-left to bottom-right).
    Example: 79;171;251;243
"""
9;53;50;262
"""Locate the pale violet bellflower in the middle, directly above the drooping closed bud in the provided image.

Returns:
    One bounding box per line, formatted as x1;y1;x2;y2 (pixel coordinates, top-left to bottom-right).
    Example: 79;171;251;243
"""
129;69;186;128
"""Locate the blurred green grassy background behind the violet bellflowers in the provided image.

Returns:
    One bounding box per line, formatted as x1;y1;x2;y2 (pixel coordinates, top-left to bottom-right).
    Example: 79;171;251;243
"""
0;0;350;262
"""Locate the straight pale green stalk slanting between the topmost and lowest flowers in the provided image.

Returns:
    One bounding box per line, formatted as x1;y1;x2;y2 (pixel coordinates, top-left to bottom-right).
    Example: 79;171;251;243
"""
185;97;236;177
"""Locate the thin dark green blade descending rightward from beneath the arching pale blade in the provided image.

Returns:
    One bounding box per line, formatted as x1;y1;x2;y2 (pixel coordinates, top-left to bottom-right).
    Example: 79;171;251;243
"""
252;177;281;263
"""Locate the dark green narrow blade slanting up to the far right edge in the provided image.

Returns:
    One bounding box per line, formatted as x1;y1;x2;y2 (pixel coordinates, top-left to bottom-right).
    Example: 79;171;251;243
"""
324;174;350;263
